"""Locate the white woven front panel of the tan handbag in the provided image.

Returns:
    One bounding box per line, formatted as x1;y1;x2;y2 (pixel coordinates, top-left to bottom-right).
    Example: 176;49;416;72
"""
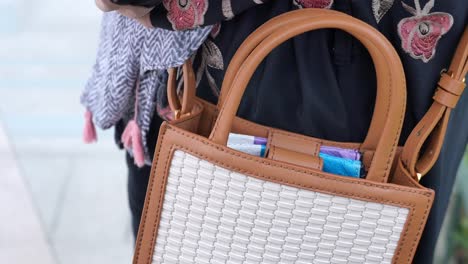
152;151;408;263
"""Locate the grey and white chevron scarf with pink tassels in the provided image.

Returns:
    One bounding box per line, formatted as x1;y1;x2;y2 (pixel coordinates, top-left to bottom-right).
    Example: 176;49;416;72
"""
81;12;211;167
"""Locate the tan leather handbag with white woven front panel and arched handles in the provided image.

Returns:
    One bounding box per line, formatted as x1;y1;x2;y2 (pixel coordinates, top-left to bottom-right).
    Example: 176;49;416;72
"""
134;9;468;264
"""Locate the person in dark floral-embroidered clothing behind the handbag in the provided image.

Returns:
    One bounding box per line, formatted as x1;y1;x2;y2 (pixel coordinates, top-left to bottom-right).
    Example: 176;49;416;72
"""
86;0;468;263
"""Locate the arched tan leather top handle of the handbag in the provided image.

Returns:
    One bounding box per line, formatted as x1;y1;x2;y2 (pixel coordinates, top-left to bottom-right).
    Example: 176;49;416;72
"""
210;9;406;182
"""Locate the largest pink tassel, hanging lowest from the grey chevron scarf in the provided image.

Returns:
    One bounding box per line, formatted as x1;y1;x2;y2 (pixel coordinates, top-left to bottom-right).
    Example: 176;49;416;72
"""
122;120;145;168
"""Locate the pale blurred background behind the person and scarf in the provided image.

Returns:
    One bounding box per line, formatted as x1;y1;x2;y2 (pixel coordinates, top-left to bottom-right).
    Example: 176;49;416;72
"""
0;0;468;264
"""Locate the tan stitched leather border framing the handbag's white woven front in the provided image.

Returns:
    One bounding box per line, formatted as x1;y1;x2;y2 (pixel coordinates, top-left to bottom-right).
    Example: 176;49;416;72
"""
134;123;434;264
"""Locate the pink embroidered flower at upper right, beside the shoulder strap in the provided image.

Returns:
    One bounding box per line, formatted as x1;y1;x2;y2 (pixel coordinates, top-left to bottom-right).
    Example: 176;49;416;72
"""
398;0;453;62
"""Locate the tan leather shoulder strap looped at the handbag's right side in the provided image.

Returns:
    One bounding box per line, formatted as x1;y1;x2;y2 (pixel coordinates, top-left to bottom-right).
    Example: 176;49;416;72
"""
401;27;468;180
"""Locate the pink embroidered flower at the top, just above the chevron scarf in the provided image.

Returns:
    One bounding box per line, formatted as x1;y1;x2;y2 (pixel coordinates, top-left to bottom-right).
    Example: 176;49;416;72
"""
163;0;208;30
